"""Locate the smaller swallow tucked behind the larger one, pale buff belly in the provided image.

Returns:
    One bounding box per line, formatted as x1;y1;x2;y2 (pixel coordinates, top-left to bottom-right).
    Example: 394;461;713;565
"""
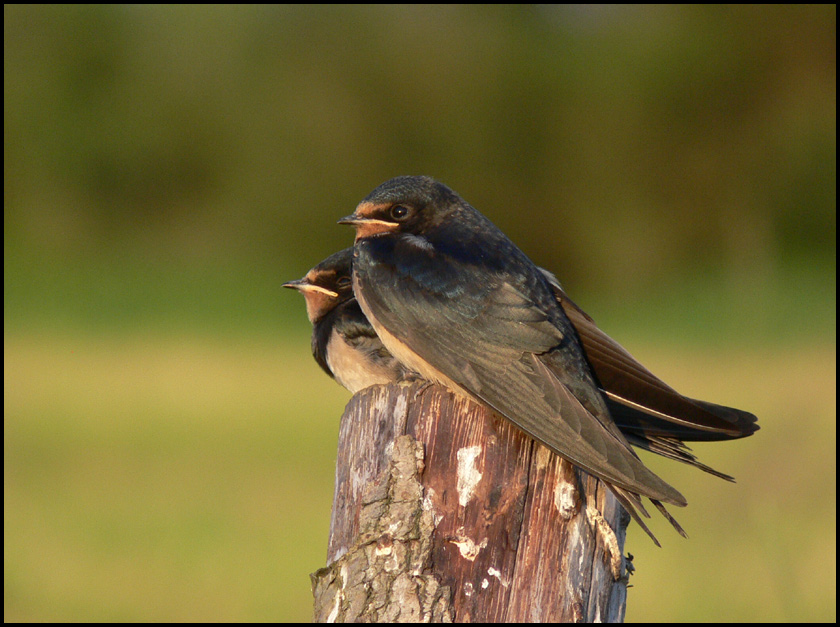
283;248;409;394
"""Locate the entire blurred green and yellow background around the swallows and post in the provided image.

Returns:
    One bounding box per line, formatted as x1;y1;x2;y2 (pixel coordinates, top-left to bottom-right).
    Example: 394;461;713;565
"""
4;5;836;621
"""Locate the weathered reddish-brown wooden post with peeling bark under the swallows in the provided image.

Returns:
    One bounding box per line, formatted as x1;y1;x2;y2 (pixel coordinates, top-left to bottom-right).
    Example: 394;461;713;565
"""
312;383;629;622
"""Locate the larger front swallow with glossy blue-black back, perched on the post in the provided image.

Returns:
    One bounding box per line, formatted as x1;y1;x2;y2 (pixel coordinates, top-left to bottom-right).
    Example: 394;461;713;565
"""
339;177;754;544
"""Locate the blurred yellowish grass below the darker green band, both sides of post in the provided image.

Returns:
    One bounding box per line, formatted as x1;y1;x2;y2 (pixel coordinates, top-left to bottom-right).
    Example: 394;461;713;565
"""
4;327;836;621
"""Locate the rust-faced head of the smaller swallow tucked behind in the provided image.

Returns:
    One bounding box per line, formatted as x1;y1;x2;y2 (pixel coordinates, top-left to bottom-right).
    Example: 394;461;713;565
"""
283;248;353;324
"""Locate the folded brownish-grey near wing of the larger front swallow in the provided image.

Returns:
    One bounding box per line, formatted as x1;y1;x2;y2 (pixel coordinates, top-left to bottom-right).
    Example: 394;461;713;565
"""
356;242;685;505
